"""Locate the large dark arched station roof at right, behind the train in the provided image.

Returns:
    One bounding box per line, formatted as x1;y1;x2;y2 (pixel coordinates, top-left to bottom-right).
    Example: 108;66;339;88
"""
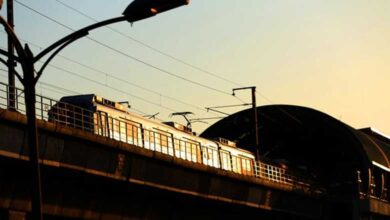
201;105;390;188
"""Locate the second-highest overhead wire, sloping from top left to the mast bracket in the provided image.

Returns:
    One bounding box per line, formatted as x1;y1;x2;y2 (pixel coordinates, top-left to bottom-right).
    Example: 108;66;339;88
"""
14;0;235;96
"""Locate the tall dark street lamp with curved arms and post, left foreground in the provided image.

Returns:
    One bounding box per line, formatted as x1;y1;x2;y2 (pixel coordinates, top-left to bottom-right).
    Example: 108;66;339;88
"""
0;0;189;220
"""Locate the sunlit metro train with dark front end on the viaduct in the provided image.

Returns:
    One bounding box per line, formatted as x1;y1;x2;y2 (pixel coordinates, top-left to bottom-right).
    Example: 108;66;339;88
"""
48;94;255;176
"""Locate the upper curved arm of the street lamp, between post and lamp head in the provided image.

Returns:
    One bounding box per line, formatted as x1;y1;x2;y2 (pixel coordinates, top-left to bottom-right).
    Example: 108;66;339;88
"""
34;16;126;63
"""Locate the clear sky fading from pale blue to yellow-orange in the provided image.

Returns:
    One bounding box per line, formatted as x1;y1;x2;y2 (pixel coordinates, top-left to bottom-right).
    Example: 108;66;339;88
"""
0;0;390;134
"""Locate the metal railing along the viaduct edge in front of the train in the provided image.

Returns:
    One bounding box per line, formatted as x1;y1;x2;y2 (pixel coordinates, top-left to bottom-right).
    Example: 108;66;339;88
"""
0;82;309;187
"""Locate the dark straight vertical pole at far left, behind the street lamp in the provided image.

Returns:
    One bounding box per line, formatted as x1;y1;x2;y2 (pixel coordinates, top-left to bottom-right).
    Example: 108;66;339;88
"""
7;0;16;109
